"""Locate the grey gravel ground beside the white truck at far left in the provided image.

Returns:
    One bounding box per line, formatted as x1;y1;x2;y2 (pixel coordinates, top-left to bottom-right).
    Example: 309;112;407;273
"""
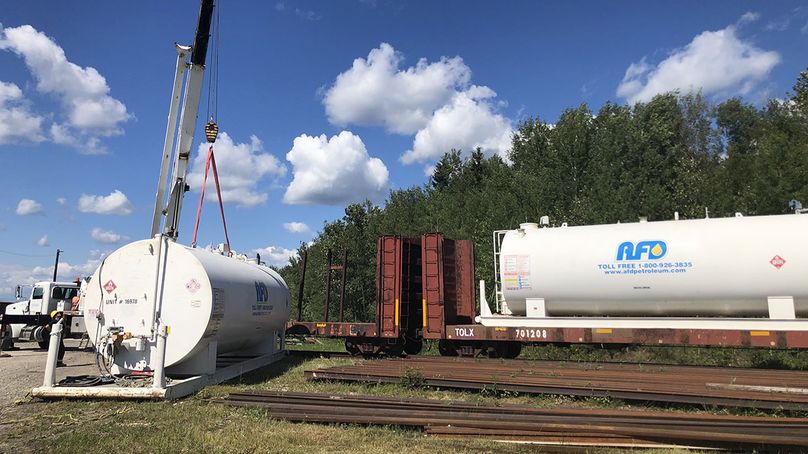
0;339;98;406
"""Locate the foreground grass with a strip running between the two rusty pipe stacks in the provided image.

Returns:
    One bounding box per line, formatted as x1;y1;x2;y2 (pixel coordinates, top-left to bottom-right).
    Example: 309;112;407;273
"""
0;358;560;453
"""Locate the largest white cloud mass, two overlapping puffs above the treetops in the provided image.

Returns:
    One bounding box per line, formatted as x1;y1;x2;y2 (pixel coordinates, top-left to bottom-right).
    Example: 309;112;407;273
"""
323;43;513;164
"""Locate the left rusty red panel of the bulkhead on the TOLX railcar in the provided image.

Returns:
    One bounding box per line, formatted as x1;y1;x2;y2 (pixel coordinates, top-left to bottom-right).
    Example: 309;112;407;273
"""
421;233;451;339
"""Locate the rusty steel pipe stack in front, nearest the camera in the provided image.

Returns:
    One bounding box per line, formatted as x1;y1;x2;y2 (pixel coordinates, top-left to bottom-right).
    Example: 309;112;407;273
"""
217;391;808;452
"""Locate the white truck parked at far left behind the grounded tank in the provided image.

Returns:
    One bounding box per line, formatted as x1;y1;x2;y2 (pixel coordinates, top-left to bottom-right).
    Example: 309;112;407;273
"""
0;280;87;350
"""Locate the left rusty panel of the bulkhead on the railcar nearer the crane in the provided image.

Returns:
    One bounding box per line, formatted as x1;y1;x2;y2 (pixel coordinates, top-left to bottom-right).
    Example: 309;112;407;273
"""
376;236;403;337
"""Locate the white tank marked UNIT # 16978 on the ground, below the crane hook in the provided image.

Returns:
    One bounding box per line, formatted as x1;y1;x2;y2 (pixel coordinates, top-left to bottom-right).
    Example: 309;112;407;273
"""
83;239;290;372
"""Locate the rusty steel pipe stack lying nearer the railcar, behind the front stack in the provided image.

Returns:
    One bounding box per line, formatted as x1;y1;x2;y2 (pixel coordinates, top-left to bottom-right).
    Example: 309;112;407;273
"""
305;357;808;411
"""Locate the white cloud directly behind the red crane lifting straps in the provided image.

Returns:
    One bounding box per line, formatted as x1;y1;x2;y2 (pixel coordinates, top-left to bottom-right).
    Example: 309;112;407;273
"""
188;132;287;207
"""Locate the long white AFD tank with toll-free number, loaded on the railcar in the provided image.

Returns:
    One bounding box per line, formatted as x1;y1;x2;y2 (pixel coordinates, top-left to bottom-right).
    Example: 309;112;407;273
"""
499;215;808;317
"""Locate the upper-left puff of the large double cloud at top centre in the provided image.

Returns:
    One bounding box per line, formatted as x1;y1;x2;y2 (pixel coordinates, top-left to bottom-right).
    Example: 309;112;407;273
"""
323;43;471;134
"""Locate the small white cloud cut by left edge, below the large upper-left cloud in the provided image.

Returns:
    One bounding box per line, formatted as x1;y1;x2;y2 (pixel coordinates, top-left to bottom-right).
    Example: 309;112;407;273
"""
0;81;45;144
